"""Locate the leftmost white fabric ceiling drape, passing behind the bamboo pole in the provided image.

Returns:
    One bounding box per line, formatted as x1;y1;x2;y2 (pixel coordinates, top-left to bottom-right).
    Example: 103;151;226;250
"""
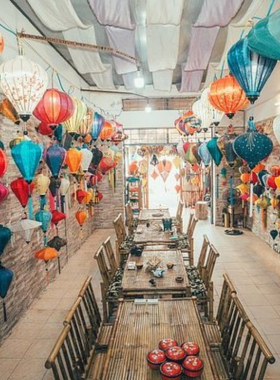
28;0;115;89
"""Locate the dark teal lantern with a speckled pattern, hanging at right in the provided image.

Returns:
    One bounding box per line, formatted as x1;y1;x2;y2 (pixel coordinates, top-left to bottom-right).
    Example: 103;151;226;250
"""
233;117;273;169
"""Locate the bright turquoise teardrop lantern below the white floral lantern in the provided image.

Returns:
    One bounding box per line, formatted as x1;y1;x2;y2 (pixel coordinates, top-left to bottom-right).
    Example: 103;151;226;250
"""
11;141;42;184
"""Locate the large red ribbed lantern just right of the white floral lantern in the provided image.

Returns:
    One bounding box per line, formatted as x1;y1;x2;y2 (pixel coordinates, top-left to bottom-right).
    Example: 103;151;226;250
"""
33;88;75;129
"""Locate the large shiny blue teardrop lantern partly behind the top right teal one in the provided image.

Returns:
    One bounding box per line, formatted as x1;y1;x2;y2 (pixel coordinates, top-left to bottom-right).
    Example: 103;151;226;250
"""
227;38;277;104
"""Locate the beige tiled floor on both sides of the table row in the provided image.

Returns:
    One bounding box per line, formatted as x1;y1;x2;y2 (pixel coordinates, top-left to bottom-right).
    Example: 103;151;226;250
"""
0;217;280;380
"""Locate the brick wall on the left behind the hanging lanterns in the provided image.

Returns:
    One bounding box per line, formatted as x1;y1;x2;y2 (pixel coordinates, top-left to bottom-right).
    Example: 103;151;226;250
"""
0;108;123;343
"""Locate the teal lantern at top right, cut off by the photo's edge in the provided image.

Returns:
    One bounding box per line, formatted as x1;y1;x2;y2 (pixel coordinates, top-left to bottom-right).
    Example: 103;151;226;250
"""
247;9;280;60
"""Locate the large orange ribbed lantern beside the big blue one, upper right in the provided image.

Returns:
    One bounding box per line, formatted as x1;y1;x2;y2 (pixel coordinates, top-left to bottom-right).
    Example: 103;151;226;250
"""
209;75;249;119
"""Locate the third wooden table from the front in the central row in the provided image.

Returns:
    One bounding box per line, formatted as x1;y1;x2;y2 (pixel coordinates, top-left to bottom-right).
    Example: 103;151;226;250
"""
133;221;177;245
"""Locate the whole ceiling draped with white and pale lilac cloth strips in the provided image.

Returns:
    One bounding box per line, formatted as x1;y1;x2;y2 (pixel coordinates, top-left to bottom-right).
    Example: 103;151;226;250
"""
15;0;280;96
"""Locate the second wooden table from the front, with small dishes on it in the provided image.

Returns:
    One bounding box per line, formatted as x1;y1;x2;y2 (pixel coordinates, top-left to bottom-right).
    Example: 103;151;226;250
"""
122;249;191;298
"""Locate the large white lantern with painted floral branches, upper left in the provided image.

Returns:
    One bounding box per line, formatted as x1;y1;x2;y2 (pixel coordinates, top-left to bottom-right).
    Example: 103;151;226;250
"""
0;55;48;121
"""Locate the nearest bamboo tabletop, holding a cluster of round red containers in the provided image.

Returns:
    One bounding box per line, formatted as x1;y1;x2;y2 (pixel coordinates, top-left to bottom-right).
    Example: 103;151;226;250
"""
101;299;218;380
